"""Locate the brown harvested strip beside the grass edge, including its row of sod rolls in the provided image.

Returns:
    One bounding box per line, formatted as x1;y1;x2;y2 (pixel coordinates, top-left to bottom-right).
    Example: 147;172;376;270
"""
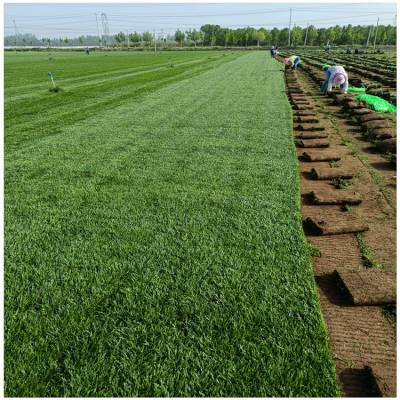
286;68;396;397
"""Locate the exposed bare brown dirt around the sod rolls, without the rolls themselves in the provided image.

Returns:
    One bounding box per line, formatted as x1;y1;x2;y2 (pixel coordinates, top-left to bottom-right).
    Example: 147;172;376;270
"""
284;67;396;397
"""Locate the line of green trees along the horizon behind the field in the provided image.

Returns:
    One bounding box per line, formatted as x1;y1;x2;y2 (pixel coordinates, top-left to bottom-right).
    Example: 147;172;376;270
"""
5;24;396;47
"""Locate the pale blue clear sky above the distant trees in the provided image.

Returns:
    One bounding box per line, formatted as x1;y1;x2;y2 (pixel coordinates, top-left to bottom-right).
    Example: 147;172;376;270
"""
4;2;397;38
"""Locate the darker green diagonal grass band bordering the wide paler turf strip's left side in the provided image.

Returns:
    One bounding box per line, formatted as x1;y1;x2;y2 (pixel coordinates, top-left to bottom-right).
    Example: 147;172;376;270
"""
5;55;244;146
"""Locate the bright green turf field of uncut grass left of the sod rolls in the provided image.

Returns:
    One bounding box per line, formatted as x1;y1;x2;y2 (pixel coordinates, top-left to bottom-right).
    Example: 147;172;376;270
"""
5;52;339;397
